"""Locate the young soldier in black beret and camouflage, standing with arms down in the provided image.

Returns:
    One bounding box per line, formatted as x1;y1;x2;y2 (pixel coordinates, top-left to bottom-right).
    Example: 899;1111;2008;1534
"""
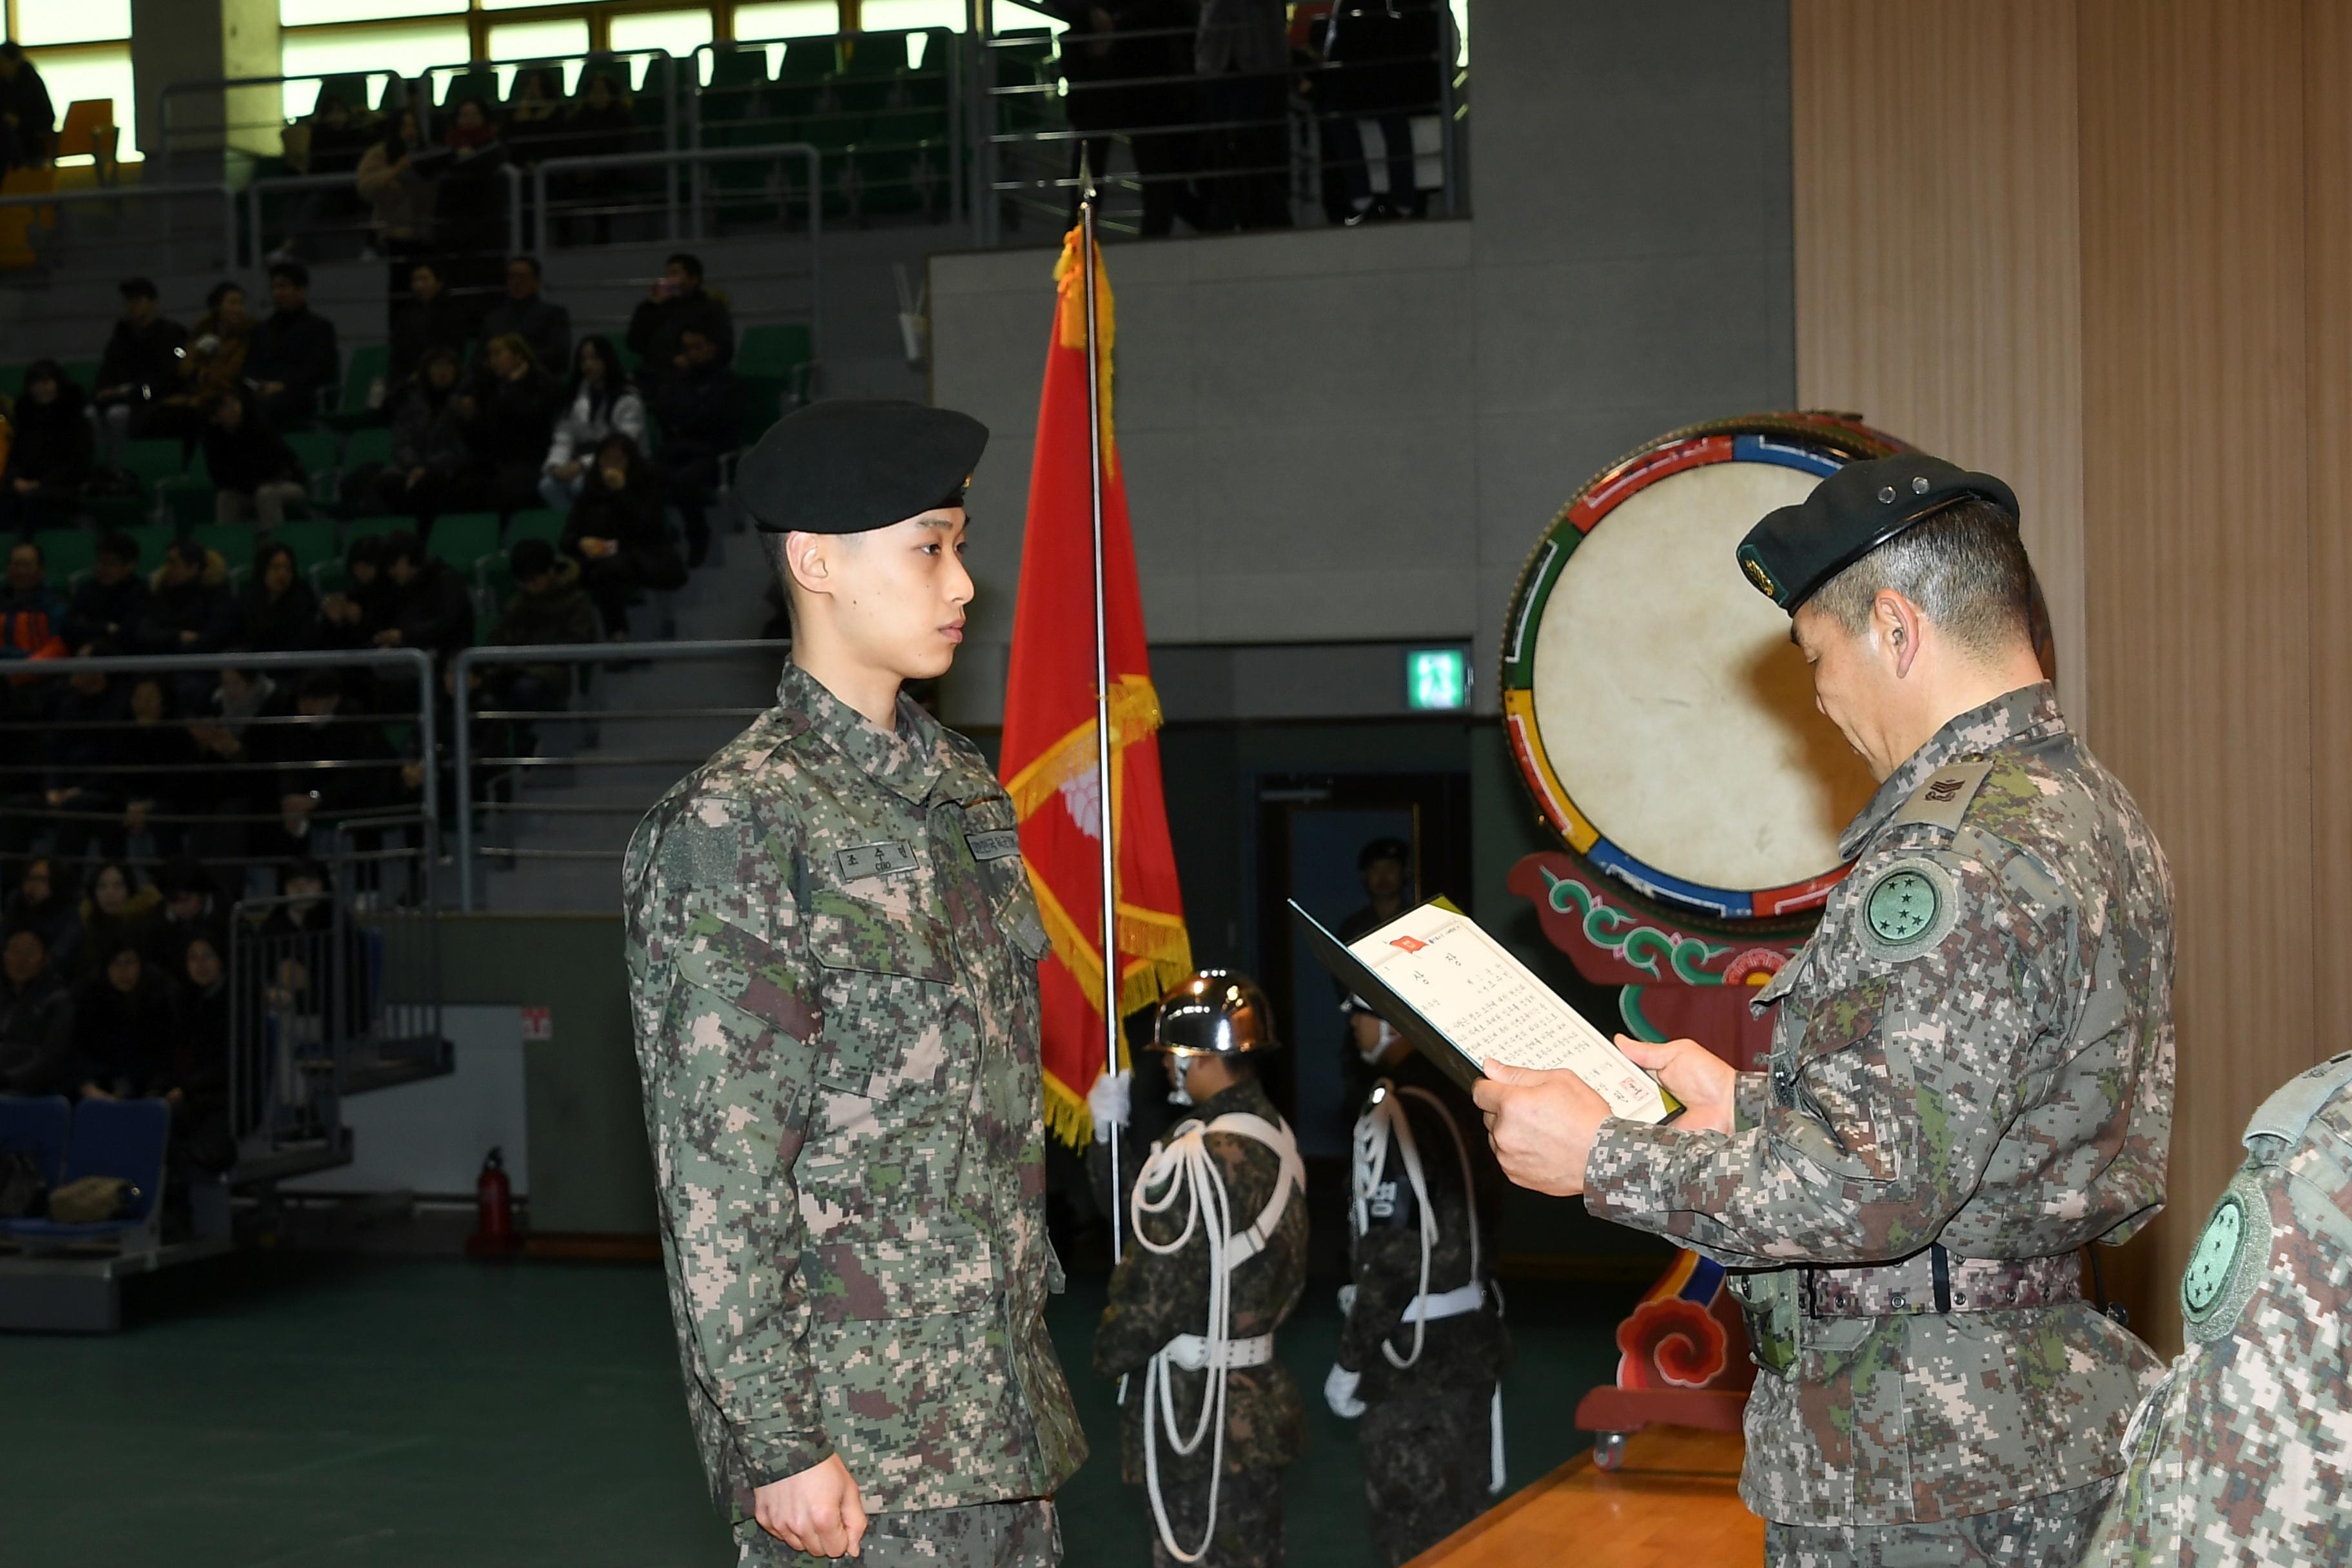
623;402;1084;1568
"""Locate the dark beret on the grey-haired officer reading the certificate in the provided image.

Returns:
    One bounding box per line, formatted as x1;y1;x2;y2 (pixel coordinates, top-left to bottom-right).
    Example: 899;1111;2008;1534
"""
1741;451;2018;616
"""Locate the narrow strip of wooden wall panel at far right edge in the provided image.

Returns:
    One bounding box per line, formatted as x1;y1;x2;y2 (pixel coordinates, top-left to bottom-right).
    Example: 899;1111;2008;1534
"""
2302;0;2352;1058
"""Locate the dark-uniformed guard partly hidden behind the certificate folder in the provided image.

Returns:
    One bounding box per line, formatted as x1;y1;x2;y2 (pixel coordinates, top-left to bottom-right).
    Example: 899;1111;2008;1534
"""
1324;997;1510;1568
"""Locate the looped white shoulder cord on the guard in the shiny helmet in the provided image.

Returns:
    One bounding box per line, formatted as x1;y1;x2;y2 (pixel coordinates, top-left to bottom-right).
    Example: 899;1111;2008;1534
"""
1126;1114;1306;1563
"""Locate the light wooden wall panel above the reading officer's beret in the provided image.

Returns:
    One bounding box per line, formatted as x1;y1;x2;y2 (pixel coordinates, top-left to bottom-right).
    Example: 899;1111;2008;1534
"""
1790;0;2086;712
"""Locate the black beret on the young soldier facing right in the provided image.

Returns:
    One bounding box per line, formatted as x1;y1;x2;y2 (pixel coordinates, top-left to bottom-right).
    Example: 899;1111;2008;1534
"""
736;397;988;534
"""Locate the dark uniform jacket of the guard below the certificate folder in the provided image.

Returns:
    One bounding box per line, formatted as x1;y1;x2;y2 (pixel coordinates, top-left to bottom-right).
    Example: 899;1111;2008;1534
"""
1338;1051;1507;1401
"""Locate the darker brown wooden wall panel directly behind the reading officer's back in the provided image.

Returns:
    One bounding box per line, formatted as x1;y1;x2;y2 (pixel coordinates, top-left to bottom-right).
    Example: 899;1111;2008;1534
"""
2079;0;2314;1345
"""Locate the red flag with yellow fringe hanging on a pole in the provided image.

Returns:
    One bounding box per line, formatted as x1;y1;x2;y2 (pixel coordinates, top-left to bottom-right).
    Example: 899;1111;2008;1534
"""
1002;228;1193;1145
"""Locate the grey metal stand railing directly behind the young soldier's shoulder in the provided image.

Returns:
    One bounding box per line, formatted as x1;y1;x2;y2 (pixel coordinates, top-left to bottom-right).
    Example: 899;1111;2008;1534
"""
451;640;792;914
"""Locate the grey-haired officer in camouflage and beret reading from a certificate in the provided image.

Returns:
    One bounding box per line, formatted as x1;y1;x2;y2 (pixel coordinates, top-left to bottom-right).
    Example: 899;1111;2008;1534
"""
1477;454;2173;1568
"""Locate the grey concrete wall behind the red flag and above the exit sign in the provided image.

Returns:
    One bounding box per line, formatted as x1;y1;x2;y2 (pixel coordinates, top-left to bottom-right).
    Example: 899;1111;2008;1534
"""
929;0;1797;724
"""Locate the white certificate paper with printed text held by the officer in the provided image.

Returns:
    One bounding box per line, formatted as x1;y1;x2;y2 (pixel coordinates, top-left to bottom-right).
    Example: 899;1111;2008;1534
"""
1348;903;1672;1124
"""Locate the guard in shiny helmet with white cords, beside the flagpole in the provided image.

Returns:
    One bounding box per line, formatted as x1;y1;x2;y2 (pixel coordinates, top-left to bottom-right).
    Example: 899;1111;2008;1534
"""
1093;968;1308;1568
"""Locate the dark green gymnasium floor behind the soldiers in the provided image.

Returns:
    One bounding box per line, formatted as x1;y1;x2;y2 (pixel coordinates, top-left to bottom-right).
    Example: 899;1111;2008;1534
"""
0;1255;1637;1568
